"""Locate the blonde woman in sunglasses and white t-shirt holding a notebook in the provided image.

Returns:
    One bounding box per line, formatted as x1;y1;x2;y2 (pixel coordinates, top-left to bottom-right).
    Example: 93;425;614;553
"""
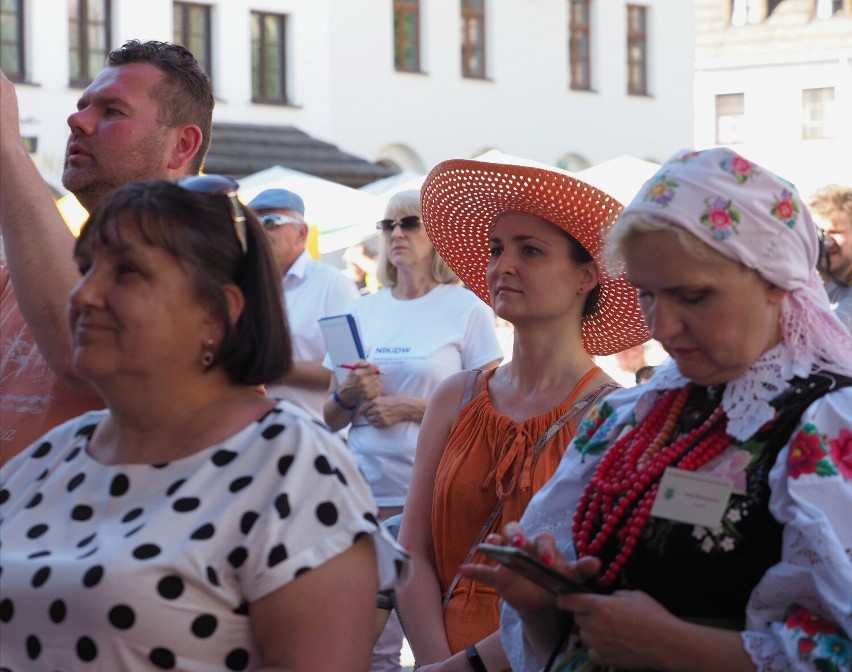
325;190;502;672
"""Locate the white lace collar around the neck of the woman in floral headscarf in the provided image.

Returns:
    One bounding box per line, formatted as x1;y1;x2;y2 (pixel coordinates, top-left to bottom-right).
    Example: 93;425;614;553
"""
636;343;796;441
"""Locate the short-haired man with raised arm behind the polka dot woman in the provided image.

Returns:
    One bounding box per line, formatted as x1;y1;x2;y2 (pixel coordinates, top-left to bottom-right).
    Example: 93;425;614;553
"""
0;40;214;462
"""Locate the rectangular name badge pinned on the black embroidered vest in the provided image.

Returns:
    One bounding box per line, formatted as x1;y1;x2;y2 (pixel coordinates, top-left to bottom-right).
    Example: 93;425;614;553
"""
651;467;733;529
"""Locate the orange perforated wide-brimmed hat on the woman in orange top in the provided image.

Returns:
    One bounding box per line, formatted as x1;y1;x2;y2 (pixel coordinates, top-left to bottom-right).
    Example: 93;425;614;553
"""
420;159;650;355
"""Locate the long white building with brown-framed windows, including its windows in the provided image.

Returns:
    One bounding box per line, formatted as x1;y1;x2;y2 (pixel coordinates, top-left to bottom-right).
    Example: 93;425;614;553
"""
0;0;693;193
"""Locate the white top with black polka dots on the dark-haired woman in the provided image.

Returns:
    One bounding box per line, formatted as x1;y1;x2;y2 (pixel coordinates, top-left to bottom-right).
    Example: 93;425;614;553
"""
0;402;406;672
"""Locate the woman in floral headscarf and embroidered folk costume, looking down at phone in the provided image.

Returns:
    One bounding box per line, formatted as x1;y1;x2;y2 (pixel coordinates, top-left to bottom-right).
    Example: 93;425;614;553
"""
465;148;852;672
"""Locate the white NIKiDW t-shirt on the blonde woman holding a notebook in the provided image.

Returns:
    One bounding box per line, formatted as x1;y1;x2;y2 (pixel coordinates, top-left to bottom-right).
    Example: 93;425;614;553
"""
340;285;503;506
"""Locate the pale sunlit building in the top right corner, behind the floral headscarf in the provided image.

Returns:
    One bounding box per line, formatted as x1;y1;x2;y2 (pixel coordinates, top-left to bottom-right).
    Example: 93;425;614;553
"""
695;0;852;194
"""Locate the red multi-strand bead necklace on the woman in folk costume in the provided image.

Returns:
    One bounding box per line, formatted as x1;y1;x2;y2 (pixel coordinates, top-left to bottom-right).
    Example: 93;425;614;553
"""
573;385;732;587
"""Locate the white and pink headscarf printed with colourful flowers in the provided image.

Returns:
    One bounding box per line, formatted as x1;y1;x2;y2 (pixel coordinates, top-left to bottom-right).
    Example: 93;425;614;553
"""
615;147;852;376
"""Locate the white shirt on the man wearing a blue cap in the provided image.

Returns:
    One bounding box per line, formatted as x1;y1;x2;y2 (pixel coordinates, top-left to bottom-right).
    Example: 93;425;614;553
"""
267;250;360;420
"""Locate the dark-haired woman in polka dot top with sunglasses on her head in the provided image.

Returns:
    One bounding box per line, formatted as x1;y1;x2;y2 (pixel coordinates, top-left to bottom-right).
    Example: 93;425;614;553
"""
0;176;407;672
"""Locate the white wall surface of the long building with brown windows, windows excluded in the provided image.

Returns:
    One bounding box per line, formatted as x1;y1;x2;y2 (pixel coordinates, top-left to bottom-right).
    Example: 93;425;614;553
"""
11;0;693;194
